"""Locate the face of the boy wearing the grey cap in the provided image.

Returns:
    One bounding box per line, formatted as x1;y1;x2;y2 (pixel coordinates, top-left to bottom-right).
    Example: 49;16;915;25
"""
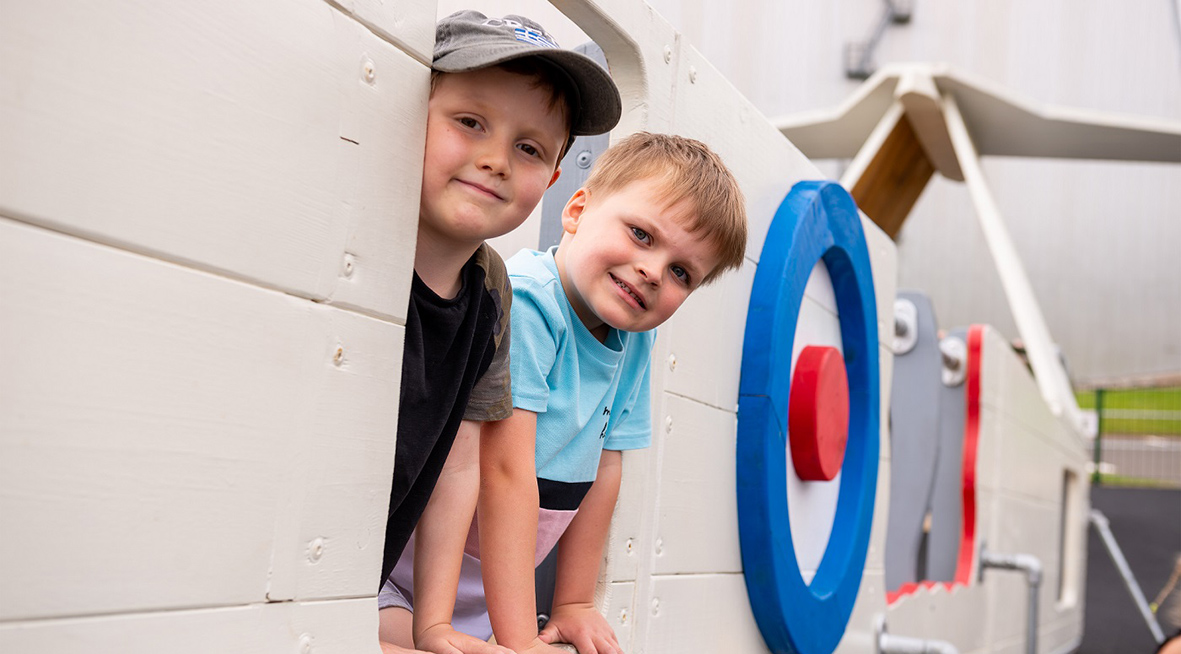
418;67;567;248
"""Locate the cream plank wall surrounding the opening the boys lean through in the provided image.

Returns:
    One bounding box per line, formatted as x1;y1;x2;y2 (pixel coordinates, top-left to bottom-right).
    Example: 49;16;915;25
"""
0;0;895;654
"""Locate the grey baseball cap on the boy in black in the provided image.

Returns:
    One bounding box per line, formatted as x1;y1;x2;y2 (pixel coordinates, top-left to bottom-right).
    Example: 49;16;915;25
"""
431;9;622;136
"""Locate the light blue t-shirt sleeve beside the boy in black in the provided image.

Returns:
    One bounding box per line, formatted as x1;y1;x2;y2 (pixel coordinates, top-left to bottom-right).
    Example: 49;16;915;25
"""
509;277;565;413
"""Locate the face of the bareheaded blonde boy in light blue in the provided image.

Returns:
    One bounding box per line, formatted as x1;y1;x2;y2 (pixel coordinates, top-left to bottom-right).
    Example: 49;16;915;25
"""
556;179;718;340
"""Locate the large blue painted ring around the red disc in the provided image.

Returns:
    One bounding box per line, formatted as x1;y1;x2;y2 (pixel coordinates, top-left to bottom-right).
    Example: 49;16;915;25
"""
737;182;881;654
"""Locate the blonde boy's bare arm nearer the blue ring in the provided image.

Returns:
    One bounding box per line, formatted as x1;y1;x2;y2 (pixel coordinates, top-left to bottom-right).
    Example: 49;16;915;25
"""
541;450;622;654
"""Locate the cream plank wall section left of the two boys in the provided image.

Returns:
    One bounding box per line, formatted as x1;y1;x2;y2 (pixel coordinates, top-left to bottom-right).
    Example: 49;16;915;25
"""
0;0;435;654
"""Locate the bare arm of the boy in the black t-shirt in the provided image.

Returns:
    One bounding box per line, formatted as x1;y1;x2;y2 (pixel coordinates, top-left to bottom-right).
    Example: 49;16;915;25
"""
403;420;510;654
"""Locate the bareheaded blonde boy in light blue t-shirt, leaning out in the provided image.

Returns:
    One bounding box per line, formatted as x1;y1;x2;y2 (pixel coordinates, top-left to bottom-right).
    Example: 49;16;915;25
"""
383;132;746;654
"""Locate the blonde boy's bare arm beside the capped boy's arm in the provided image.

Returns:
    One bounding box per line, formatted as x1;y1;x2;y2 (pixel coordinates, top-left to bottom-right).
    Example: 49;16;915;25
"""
477;408;560;653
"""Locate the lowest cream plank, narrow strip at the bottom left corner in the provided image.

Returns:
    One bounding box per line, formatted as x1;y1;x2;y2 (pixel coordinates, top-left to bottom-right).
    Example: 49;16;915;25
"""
0;597;378;654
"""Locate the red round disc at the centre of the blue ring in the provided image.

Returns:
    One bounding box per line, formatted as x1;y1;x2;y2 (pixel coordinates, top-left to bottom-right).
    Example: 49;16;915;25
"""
788;345;849;482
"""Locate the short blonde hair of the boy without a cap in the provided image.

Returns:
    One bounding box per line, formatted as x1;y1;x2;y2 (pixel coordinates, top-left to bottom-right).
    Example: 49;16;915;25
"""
586;132;746;285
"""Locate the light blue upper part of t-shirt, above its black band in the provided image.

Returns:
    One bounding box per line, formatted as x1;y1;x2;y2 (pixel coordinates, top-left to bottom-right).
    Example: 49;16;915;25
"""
505;248;655;484
